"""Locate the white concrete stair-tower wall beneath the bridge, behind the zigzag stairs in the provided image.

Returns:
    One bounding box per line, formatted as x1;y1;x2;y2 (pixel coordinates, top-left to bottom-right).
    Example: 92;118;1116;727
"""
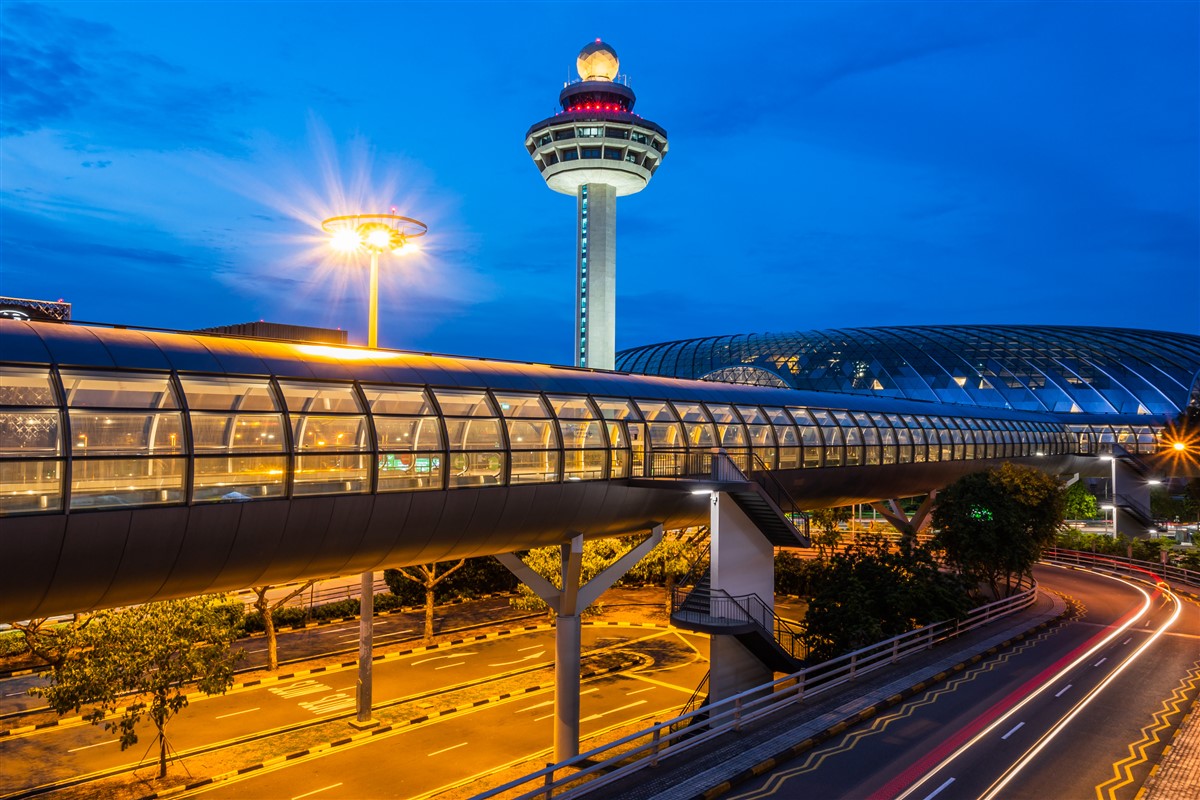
708;492;775;703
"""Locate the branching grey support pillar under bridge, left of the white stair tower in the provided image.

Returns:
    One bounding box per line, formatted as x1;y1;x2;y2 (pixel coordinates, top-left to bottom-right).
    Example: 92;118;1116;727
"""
496;525;662;763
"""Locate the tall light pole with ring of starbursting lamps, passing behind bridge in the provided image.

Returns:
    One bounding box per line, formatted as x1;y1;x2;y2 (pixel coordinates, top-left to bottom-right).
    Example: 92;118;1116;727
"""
320;213;430;728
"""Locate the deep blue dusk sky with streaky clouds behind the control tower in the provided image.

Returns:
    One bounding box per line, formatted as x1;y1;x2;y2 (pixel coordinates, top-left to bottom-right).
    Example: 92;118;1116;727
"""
0;0;1200;363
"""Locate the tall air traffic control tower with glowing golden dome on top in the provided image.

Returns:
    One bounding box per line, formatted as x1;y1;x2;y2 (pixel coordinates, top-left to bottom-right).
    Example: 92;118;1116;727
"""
526;40;667;369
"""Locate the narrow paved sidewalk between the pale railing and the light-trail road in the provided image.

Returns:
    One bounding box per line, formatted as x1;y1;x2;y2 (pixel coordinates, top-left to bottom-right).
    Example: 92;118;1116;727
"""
581;593;1065;800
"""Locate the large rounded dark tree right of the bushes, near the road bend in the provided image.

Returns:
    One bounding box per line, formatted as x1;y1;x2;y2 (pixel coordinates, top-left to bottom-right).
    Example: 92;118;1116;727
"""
934;464;1064;599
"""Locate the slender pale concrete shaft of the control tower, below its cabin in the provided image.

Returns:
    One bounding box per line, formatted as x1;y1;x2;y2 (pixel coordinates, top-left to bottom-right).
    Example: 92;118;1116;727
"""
575;184;617;369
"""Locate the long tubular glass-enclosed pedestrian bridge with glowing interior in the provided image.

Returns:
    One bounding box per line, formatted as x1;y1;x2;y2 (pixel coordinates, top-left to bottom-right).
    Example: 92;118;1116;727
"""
0;320;1123;620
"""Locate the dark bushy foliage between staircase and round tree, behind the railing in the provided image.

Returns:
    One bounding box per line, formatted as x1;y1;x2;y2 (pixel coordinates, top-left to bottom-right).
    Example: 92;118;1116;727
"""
804;534;971;661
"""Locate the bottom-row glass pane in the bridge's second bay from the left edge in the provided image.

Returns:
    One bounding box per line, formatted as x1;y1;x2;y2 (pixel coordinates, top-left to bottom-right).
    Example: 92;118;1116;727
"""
71;458;186;510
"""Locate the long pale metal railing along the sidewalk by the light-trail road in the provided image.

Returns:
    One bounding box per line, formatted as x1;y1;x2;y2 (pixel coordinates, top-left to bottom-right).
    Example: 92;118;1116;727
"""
474;584;1037;800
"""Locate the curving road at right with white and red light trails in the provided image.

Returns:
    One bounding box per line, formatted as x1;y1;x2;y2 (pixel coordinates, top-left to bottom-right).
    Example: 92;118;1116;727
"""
731;567;1200;800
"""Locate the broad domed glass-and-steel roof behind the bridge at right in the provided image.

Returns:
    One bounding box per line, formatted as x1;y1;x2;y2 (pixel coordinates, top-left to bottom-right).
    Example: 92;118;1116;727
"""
617;325;1200;425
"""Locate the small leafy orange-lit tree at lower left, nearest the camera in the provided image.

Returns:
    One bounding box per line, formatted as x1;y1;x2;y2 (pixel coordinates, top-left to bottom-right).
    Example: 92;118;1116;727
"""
31;595;242;777
